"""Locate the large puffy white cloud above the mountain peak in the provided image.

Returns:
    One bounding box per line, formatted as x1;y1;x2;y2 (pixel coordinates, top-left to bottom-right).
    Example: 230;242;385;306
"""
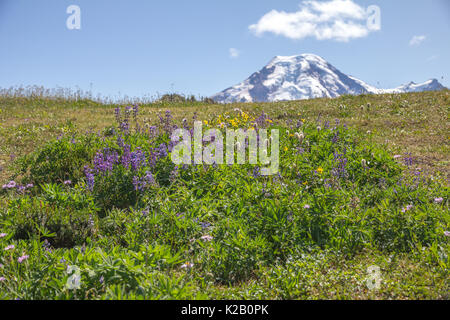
249;0;380;42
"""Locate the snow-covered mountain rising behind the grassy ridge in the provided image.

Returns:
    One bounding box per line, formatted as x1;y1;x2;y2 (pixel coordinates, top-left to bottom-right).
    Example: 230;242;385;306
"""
211;54;444;103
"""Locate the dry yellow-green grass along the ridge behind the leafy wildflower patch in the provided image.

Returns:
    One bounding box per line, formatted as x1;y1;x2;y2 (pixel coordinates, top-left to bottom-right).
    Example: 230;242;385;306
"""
0;90;450;180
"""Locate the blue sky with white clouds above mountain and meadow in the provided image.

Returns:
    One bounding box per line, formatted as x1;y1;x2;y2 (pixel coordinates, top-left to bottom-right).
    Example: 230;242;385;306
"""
0;0;450;96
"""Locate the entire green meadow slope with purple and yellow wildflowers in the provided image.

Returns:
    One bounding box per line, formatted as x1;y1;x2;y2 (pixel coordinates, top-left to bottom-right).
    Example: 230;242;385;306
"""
0;90;450;299
